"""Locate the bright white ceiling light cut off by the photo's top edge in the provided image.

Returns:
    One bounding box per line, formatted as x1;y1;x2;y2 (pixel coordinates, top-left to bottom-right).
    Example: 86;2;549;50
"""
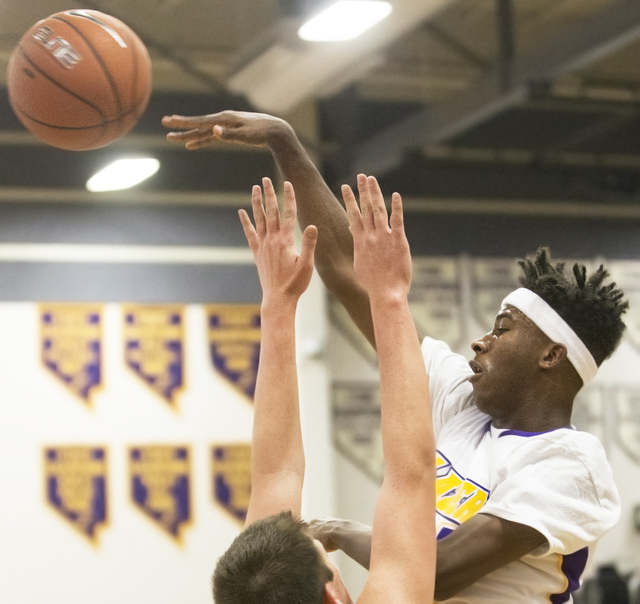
298;0;391;42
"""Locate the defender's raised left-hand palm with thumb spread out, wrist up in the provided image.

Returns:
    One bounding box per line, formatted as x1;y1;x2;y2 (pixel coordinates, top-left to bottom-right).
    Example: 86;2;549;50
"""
238;178;318;303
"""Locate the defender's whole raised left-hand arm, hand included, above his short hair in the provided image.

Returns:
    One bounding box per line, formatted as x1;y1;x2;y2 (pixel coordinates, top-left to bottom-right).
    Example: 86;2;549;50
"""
239;178;317;527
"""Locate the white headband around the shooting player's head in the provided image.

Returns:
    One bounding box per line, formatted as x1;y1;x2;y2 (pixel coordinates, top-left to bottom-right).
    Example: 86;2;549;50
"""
502;287;598;386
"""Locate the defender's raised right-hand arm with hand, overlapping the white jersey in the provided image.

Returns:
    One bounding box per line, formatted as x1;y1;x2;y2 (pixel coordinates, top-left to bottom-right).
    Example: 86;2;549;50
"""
343;175;436;604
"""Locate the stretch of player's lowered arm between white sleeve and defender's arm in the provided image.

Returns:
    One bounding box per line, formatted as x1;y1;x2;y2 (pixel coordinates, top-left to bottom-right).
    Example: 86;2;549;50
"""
435;514;546;600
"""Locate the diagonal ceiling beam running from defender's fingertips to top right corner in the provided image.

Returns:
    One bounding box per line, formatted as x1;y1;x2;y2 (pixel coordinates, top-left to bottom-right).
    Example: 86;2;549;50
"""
343;0;640;181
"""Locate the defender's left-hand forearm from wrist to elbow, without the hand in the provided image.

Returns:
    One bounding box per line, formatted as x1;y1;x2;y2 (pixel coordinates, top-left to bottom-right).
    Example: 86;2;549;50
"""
251;301;304;482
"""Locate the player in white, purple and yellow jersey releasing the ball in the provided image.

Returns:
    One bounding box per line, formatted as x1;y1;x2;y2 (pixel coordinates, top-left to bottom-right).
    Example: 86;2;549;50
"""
164;112;628;604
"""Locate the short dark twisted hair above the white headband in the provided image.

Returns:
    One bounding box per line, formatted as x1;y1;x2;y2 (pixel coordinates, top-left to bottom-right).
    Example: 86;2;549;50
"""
518;247;629;365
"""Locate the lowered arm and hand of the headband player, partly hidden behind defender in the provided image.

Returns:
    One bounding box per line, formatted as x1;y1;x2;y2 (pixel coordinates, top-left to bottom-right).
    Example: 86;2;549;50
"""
311;514;546;601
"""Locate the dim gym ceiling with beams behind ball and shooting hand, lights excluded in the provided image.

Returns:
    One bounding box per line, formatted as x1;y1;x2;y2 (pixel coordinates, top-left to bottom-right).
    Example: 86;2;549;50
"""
0;0;640;220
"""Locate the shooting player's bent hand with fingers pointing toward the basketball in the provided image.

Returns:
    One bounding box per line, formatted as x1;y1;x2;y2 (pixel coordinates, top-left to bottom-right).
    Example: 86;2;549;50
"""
162;111;295;149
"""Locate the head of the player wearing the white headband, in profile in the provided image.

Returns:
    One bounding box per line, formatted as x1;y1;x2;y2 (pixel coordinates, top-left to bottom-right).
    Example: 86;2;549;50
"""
470;248;629;417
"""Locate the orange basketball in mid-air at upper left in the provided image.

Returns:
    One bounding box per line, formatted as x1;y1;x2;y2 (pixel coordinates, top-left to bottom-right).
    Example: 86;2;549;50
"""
7;10;151;151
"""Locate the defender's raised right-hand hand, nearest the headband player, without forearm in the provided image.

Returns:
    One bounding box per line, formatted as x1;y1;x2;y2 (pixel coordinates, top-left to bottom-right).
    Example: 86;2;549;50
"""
342;174;411;299
